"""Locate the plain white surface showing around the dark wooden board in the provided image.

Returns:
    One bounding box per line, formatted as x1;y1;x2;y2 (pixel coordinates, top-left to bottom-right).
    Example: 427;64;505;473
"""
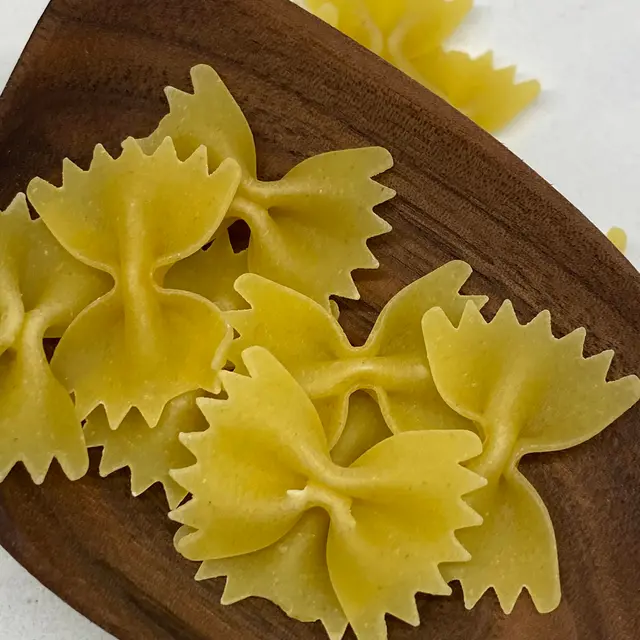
0;0;640;640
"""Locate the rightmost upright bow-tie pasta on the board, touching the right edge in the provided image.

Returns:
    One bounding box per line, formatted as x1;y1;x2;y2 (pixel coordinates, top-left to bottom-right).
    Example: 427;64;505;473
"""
423;303;640;612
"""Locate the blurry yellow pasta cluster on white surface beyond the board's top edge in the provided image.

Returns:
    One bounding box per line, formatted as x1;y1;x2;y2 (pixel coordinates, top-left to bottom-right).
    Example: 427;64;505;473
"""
305;0;540;131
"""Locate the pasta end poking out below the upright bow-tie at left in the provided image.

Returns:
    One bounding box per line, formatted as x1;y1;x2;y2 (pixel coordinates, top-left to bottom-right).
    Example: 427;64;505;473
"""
84;391;208;509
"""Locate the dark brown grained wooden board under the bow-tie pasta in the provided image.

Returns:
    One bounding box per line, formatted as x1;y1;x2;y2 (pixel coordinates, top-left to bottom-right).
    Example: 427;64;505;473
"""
0;0;640;640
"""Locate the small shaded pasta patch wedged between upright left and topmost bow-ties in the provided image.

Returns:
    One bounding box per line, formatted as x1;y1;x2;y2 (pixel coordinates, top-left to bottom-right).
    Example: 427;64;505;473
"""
164;229;249;311
